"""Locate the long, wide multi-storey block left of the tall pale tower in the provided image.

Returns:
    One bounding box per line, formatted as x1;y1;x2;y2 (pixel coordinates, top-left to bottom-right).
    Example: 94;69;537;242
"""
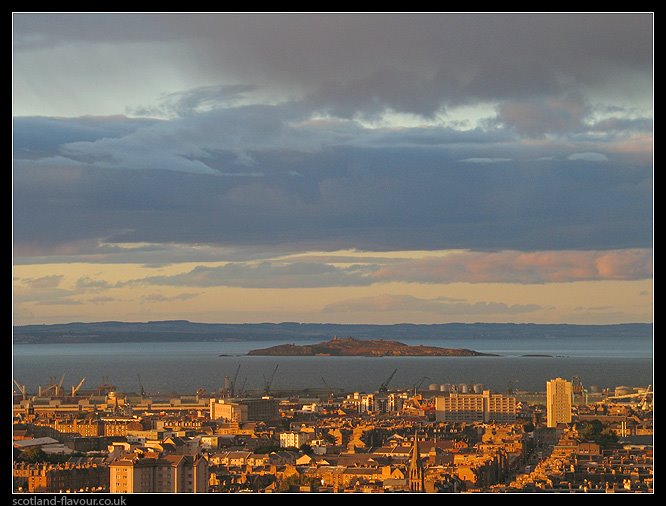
435;390;516;422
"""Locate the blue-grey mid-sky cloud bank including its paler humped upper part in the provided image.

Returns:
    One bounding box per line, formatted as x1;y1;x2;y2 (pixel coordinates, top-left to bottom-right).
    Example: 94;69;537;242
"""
14;109;652;256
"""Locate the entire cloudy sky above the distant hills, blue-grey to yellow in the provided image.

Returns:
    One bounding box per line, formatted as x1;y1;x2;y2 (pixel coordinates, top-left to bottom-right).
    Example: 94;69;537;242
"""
13;13;654;325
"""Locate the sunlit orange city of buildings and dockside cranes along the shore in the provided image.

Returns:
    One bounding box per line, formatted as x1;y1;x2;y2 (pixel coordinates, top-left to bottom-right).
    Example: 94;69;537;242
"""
13;366;654;493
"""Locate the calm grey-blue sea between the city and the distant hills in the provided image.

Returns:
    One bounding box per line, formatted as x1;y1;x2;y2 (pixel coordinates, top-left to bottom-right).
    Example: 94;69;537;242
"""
13;338;653;394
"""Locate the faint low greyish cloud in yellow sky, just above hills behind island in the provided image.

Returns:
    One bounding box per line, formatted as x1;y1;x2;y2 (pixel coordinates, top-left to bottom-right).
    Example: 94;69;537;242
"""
322;294;543;315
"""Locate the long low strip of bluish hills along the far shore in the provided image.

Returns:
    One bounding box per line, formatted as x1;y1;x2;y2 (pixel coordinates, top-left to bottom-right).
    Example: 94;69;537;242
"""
14;320;652;343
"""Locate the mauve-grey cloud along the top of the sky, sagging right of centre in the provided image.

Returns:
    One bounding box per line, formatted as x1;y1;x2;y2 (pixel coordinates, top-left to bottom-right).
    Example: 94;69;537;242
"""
14;14;653;117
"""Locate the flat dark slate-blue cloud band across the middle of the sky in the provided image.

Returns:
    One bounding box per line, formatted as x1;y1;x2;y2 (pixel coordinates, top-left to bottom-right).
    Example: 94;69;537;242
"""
14;133;652;256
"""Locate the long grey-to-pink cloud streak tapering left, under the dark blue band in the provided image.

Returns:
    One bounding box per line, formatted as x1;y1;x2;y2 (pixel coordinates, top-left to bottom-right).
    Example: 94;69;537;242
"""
119;250;652;288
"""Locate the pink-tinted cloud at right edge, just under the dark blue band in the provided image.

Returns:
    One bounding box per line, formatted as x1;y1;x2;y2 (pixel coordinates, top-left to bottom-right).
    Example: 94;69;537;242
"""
371;250;652;283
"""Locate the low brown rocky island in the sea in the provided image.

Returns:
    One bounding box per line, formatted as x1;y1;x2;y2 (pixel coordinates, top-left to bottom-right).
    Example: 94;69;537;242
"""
248;337;497;357
